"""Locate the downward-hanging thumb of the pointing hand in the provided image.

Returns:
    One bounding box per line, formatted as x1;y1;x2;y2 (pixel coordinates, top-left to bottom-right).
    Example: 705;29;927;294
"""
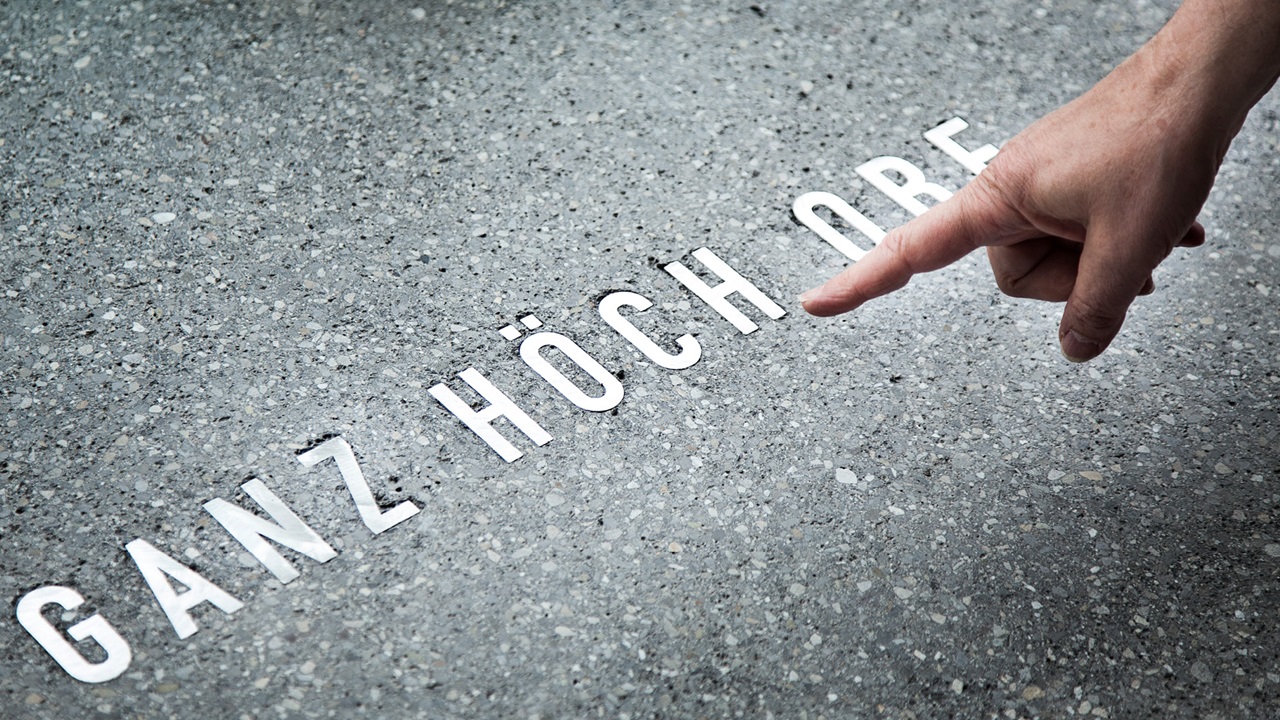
1057;224;1158;363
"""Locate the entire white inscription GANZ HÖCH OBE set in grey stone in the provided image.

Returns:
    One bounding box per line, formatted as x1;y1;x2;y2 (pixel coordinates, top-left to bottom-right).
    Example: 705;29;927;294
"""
17;118;996;683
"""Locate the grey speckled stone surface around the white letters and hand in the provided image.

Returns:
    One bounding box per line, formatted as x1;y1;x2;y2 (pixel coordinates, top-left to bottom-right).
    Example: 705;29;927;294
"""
0;0;1280;719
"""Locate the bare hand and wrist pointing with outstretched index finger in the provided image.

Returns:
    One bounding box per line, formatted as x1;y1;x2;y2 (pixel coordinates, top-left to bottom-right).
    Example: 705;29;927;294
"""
800;0;1280;361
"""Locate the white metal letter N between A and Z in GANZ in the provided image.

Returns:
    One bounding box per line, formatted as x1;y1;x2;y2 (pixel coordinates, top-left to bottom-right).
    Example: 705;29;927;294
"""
205;478;338;583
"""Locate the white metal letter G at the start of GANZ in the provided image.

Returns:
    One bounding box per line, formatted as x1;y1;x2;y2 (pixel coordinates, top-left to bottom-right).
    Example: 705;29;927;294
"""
18;585;133;683
